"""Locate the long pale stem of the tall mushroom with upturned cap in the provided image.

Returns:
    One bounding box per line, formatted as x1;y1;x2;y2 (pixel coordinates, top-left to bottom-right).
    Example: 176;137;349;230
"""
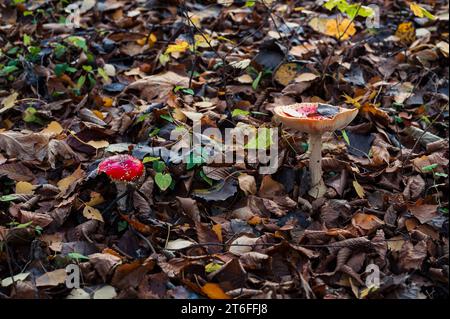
308;133;326;198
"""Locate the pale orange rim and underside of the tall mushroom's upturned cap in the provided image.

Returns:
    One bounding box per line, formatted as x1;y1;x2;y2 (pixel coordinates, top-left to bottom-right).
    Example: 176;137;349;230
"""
273;103;358;134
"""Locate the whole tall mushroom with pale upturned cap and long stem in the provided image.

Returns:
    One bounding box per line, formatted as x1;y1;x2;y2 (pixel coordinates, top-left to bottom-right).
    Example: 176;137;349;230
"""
274;103;358;198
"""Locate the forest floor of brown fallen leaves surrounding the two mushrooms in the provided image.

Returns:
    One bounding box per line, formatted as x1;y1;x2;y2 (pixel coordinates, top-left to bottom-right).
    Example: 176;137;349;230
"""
0;0;449;299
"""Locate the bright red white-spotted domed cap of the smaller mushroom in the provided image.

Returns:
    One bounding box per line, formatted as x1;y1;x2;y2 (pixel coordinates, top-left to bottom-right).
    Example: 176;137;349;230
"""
98;155;144;182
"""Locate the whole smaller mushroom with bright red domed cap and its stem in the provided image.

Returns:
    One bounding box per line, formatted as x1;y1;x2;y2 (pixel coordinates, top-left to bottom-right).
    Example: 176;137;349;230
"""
98;155;144;211
